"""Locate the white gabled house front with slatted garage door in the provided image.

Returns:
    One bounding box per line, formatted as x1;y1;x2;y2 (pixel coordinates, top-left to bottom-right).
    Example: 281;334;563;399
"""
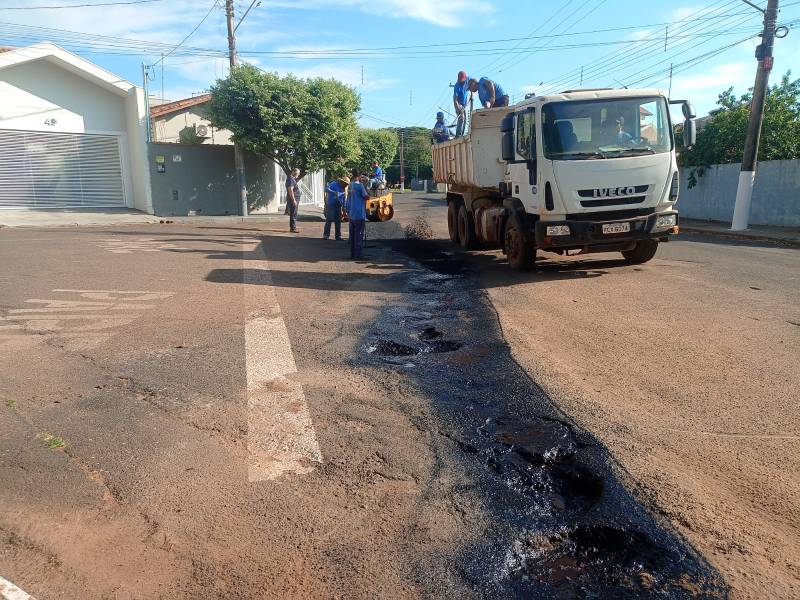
0;43;152;213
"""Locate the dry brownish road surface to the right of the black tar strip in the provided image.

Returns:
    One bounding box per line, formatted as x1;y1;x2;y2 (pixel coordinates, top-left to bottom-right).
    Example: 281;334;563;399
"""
397;196;800;598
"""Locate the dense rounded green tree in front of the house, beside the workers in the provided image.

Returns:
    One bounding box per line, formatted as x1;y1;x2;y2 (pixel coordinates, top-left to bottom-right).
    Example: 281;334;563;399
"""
206;65;361;178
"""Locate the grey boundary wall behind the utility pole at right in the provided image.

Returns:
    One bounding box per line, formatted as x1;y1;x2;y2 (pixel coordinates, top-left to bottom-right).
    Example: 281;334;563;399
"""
678;160;800;227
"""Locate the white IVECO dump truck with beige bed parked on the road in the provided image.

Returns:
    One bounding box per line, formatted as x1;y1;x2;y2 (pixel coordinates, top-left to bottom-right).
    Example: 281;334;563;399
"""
432;89;695;270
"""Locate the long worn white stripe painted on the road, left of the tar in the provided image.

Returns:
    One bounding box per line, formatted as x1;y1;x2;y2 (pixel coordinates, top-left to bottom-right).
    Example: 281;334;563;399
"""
243;241;322;481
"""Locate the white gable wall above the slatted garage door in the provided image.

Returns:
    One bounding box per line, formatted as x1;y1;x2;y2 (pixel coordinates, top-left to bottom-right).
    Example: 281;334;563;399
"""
0;59;127;133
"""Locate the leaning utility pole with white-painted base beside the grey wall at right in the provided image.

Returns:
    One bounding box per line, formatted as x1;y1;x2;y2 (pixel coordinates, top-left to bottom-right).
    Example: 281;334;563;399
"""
731;0;778;231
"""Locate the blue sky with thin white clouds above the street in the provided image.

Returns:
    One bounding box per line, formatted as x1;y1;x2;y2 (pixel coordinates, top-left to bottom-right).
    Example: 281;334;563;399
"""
0;0;800;127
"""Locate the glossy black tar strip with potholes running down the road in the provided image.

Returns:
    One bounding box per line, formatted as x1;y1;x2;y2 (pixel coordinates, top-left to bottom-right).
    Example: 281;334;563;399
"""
364;231;728;598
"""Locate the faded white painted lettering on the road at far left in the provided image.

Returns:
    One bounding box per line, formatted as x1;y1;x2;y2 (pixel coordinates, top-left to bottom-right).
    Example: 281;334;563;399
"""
0;289;173;350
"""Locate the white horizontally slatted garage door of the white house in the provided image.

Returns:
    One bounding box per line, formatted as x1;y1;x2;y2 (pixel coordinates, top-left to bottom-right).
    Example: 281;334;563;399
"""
0;129;125;209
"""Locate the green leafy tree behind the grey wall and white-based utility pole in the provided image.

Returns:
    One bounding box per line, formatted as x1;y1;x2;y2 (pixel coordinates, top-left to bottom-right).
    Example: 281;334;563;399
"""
679;72;800;187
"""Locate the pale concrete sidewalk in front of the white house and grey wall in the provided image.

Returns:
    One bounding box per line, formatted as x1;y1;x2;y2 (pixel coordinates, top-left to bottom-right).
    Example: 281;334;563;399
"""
0;205;324;227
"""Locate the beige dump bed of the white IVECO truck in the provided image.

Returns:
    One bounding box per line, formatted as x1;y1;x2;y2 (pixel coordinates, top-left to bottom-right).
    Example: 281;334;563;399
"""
431;107;512;188
